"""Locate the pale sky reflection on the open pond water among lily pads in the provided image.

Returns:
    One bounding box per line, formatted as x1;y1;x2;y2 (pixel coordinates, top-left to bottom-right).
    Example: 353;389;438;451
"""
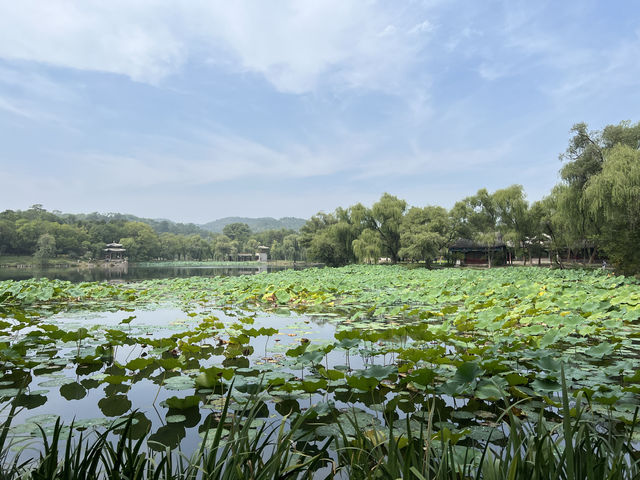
0;308;344;458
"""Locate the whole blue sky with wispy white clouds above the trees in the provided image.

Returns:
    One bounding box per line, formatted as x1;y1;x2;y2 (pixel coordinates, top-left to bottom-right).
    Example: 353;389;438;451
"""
0;0;640;223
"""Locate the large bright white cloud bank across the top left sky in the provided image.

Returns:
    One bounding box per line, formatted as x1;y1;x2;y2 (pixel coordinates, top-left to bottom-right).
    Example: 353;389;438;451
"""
0;0;436;93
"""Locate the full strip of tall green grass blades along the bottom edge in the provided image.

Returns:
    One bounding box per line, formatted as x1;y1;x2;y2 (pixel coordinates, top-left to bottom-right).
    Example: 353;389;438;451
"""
0;380;640;480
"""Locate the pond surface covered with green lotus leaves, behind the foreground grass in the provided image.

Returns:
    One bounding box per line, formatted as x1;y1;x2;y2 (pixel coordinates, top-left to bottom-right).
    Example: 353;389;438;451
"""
0;266;640;458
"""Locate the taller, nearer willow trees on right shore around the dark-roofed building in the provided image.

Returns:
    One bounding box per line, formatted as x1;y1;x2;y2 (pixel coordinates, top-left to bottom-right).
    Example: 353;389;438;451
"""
300;122;640;273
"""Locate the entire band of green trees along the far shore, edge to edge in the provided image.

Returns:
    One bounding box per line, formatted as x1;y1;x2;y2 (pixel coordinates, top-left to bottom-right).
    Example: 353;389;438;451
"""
0;122;640;273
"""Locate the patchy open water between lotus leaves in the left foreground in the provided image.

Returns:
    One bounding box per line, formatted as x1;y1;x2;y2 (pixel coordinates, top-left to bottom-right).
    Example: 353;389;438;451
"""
0;307;374;460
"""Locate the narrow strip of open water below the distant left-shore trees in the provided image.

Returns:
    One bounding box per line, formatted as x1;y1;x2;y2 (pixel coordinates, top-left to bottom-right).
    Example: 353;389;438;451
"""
0;263;300;282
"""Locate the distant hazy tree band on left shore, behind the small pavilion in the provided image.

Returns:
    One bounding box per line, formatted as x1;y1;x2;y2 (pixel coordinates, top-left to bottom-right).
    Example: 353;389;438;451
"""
0;205;303;263
